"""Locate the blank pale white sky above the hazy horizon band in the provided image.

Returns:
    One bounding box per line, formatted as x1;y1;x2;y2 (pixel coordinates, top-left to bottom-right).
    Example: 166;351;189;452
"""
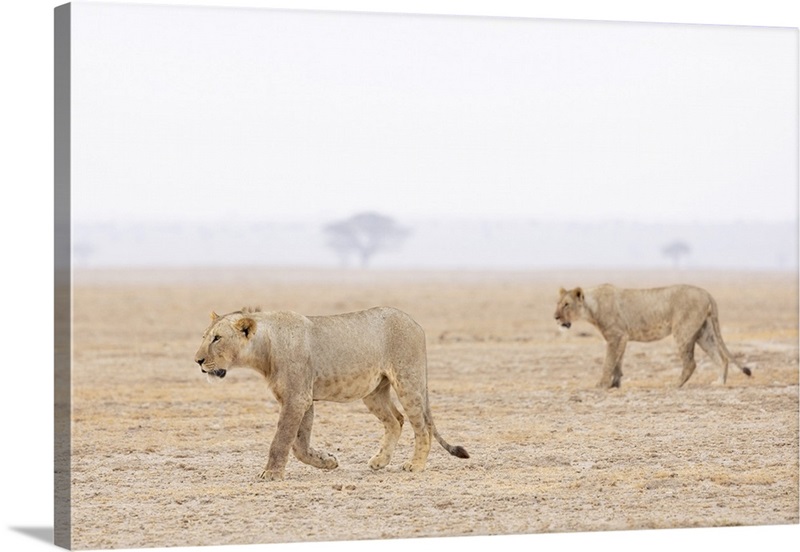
72;3;798;222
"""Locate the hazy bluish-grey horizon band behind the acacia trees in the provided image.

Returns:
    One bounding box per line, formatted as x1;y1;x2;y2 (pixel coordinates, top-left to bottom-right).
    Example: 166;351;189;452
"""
72;218;798;271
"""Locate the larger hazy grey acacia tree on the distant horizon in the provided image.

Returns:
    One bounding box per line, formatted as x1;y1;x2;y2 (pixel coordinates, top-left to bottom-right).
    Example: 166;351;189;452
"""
324;212;410;267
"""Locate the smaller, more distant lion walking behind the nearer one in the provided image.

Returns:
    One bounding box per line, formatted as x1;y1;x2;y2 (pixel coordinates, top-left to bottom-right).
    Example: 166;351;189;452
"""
555;284;751;388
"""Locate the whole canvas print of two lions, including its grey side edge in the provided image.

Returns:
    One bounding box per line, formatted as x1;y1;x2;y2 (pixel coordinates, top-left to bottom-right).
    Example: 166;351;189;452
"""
54;3;799;549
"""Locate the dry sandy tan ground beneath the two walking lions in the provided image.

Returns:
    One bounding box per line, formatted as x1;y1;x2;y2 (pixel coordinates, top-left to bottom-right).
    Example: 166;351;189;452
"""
65;269;798;549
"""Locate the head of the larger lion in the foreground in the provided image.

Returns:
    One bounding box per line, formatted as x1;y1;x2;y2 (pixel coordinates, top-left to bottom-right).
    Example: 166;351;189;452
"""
194;309;256;379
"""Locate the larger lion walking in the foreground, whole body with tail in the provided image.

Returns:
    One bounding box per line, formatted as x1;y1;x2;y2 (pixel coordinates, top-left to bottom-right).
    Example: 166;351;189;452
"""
195;307;469;481
